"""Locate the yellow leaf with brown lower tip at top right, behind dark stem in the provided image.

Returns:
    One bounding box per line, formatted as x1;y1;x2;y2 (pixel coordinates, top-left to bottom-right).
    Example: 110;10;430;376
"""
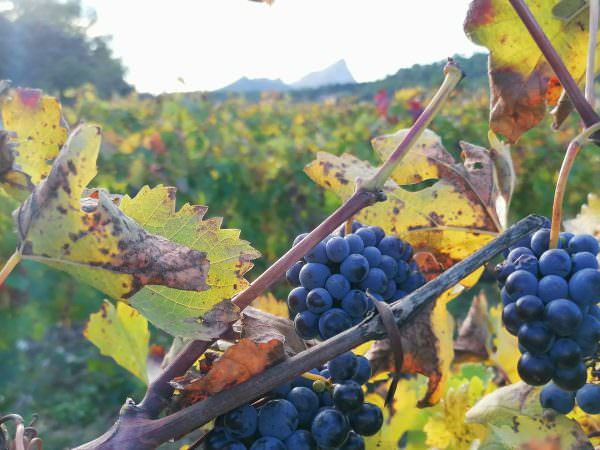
465;0;600;142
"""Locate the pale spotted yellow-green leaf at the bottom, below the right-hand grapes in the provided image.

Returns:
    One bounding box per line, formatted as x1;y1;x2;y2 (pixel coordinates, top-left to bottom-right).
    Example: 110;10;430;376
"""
465;382;593;450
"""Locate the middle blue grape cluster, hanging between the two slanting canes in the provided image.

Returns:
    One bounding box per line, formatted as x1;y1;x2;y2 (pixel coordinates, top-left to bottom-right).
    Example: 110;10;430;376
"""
286;221;425;340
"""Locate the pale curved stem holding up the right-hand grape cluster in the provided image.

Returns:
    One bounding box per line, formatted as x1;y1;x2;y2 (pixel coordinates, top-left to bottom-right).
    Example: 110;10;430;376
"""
549;123;600;248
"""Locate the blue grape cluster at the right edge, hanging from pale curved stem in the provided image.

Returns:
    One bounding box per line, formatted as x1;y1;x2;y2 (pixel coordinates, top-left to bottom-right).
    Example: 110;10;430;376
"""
495;228;600;414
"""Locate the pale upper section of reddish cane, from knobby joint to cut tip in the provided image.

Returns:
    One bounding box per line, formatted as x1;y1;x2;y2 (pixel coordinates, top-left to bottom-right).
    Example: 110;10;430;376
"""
358;58;465;190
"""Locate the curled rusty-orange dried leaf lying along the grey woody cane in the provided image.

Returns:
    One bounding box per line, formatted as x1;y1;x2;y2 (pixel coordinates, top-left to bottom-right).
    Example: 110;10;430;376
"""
171;338;285;404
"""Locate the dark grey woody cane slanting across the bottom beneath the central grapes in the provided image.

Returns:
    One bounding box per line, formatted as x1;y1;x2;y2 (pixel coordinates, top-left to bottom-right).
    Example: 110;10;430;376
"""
75;216;544;450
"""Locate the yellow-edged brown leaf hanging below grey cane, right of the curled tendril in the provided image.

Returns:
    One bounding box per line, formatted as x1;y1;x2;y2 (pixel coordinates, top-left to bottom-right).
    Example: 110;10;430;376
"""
366;299;454;407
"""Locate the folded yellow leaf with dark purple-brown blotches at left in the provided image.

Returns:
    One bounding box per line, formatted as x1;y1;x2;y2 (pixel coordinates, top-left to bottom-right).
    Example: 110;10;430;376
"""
14;125;209;298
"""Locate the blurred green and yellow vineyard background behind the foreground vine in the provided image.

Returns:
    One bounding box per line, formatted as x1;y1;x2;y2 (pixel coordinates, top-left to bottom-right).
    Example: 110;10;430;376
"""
0;2;600;448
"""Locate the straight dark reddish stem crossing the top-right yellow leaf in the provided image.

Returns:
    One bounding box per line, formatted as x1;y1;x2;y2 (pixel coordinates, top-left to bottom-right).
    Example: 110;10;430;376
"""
509;0;600;127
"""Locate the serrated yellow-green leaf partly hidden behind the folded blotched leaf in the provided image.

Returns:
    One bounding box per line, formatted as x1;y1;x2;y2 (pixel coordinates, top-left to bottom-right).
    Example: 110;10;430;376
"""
119;186;260;339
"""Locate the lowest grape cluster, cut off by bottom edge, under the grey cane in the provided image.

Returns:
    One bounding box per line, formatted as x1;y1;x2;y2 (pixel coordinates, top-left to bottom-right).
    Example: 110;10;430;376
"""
204;352;383;450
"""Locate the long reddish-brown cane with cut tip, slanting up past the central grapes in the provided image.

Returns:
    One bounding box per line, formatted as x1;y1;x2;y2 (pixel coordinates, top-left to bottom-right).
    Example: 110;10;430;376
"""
139;58;463;418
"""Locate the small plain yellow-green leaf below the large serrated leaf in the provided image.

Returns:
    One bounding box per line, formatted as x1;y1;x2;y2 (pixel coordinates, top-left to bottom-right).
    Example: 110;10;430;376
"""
83;301;150;383
